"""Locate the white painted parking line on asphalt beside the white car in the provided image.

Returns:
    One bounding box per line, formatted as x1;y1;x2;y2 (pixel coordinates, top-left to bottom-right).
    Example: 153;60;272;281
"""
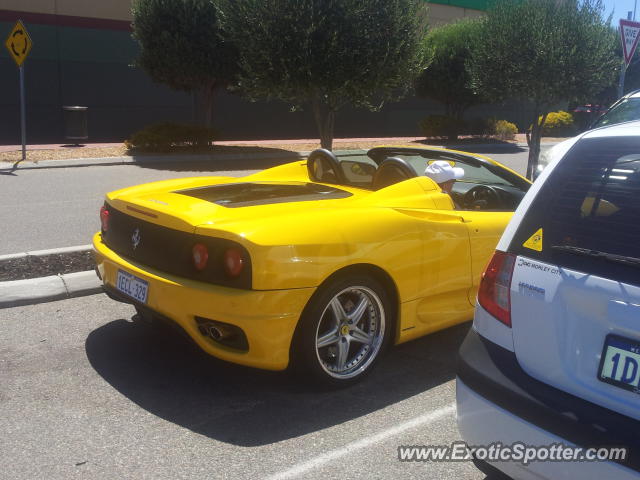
267;403;456;480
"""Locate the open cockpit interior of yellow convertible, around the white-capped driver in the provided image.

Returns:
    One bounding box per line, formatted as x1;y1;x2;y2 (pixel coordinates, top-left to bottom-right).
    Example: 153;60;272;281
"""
307;147;530;211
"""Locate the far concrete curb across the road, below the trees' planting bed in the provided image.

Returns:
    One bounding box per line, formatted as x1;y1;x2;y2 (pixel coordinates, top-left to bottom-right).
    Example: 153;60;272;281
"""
0;143;554;172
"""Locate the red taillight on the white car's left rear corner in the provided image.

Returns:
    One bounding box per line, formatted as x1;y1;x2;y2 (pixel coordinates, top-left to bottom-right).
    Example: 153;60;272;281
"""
478;250;516;327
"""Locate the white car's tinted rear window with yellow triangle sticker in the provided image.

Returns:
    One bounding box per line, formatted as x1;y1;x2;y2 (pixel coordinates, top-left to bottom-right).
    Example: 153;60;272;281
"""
509;137;640;284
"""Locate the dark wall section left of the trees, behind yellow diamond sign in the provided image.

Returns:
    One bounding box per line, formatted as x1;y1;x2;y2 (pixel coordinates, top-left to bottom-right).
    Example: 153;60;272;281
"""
0;7;193;144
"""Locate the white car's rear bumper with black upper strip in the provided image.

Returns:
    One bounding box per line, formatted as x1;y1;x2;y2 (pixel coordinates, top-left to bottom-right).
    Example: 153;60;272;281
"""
456;330;640;480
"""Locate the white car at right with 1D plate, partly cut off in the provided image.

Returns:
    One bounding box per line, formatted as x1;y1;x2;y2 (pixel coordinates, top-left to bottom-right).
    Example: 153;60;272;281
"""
456;121;640;480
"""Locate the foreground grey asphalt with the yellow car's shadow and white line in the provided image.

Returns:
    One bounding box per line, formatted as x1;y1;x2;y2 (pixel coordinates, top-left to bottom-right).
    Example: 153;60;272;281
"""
0;295;485;480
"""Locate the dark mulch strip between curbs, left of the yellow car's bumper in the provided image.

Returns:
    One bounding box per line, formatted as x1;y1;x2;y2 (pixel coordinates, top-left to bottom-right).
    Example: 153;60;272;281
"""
0;251;95;282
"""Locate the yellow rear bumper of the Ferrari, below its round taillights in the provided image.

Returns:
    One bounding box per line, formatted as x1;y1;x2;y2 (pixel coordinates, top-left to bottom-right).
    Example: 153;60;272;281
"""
93;233;315;370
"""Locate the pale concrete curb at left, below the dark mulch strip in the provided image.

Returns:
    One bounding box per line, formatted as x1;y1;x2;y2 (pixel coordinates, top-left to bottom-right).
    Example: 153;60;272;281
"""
0;270;102;309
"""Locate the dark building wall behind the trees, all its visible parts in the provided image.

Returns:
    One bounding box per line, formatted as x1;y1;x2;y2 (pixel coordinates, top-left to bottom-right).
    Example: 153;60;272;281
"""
0;0;504;144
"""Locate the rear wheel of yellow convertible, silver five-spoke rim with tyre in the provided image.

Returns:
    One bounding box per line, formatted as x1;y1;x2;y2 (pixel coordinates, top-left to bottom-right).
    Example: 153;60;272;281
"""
292;274;395;387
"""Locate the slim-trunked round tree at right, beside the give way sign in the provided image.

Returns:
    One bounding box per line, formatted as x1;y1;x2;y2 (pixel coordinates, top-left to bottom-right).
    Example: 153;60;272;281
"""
468;0;619;178
